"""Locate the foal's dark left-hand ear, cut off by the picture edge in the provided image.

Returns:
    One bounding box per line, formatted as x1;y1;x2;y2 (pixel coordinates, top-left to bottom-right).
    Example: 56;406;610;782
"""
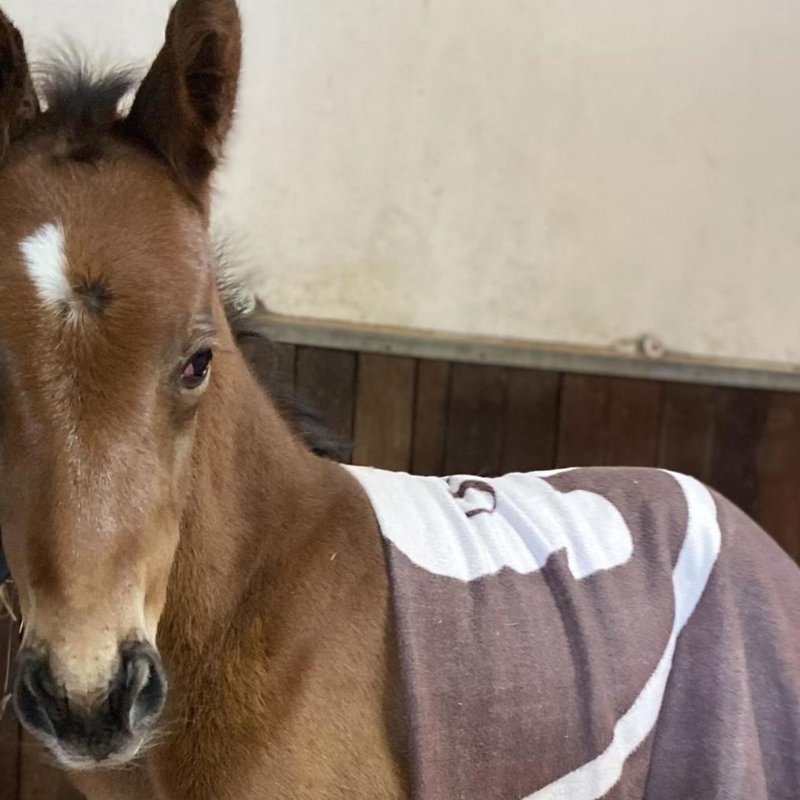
0;11;39;158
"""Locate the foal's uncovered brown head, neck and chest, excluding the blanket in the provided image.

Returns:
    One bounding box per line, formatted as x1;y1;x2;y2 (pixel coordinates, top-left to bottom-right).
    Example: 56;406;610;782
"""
0;0;406;800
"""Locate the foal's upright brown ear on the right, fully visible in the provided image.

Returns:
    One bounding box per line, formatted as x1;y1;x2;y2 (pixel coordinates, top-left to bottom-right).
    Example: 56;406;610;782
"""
126;0;242;205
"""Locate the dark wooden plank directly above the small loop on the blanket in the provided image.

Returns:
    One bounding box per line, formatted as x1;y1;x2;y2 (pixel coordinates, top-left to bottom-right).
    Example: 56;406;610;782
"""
444;364;508;475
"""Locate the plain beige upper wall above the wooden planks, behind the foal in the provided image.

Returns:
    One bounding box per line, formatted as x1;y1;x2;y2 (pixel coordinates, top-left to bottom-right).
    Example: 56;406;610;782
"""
6;0;800;363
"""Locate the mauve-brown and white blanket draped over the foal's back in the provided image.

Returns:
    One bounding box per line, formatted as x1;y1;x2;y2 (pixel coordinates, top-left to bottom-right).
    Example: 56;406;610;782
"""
351;467;800;800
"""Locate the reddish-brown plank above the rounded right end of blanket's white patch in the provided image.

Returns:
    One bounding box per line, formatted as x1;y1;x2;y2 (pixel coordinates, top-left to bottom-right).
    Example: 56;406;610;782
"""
556;375;611;467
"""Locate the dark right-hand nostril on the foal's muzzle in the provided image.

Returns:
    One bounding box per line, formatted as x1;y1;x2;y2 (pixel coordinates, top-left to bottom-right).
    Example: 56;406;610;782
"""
112;642;167;732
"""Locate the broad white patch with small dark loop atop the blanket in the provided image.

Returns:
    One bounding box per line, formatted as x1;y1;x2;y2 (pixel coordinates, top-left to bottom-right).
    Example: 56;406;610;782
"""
348;467;633;581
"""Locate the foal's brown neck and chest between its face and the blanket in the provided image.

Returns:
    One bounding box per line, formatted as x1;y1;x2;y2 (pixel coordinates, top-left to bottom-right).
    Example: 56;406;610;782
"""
151;352;407;798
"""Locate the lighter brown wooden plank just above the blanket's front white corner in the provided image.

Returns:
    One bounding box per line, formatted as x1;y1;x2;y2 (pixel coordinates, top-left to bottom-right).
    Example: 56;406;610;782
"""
353;353;416;472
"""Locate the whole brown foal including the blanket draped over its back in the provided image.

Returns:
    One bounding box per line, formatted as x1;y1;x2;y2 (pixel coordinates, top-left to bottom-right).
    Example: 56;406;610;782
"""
0;0;800;800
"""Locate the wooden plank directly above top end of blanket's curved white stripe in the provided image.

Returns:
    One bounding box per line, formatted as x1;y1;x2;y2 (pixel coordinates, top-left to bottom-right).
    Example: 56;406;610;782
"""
658;383;717;482
